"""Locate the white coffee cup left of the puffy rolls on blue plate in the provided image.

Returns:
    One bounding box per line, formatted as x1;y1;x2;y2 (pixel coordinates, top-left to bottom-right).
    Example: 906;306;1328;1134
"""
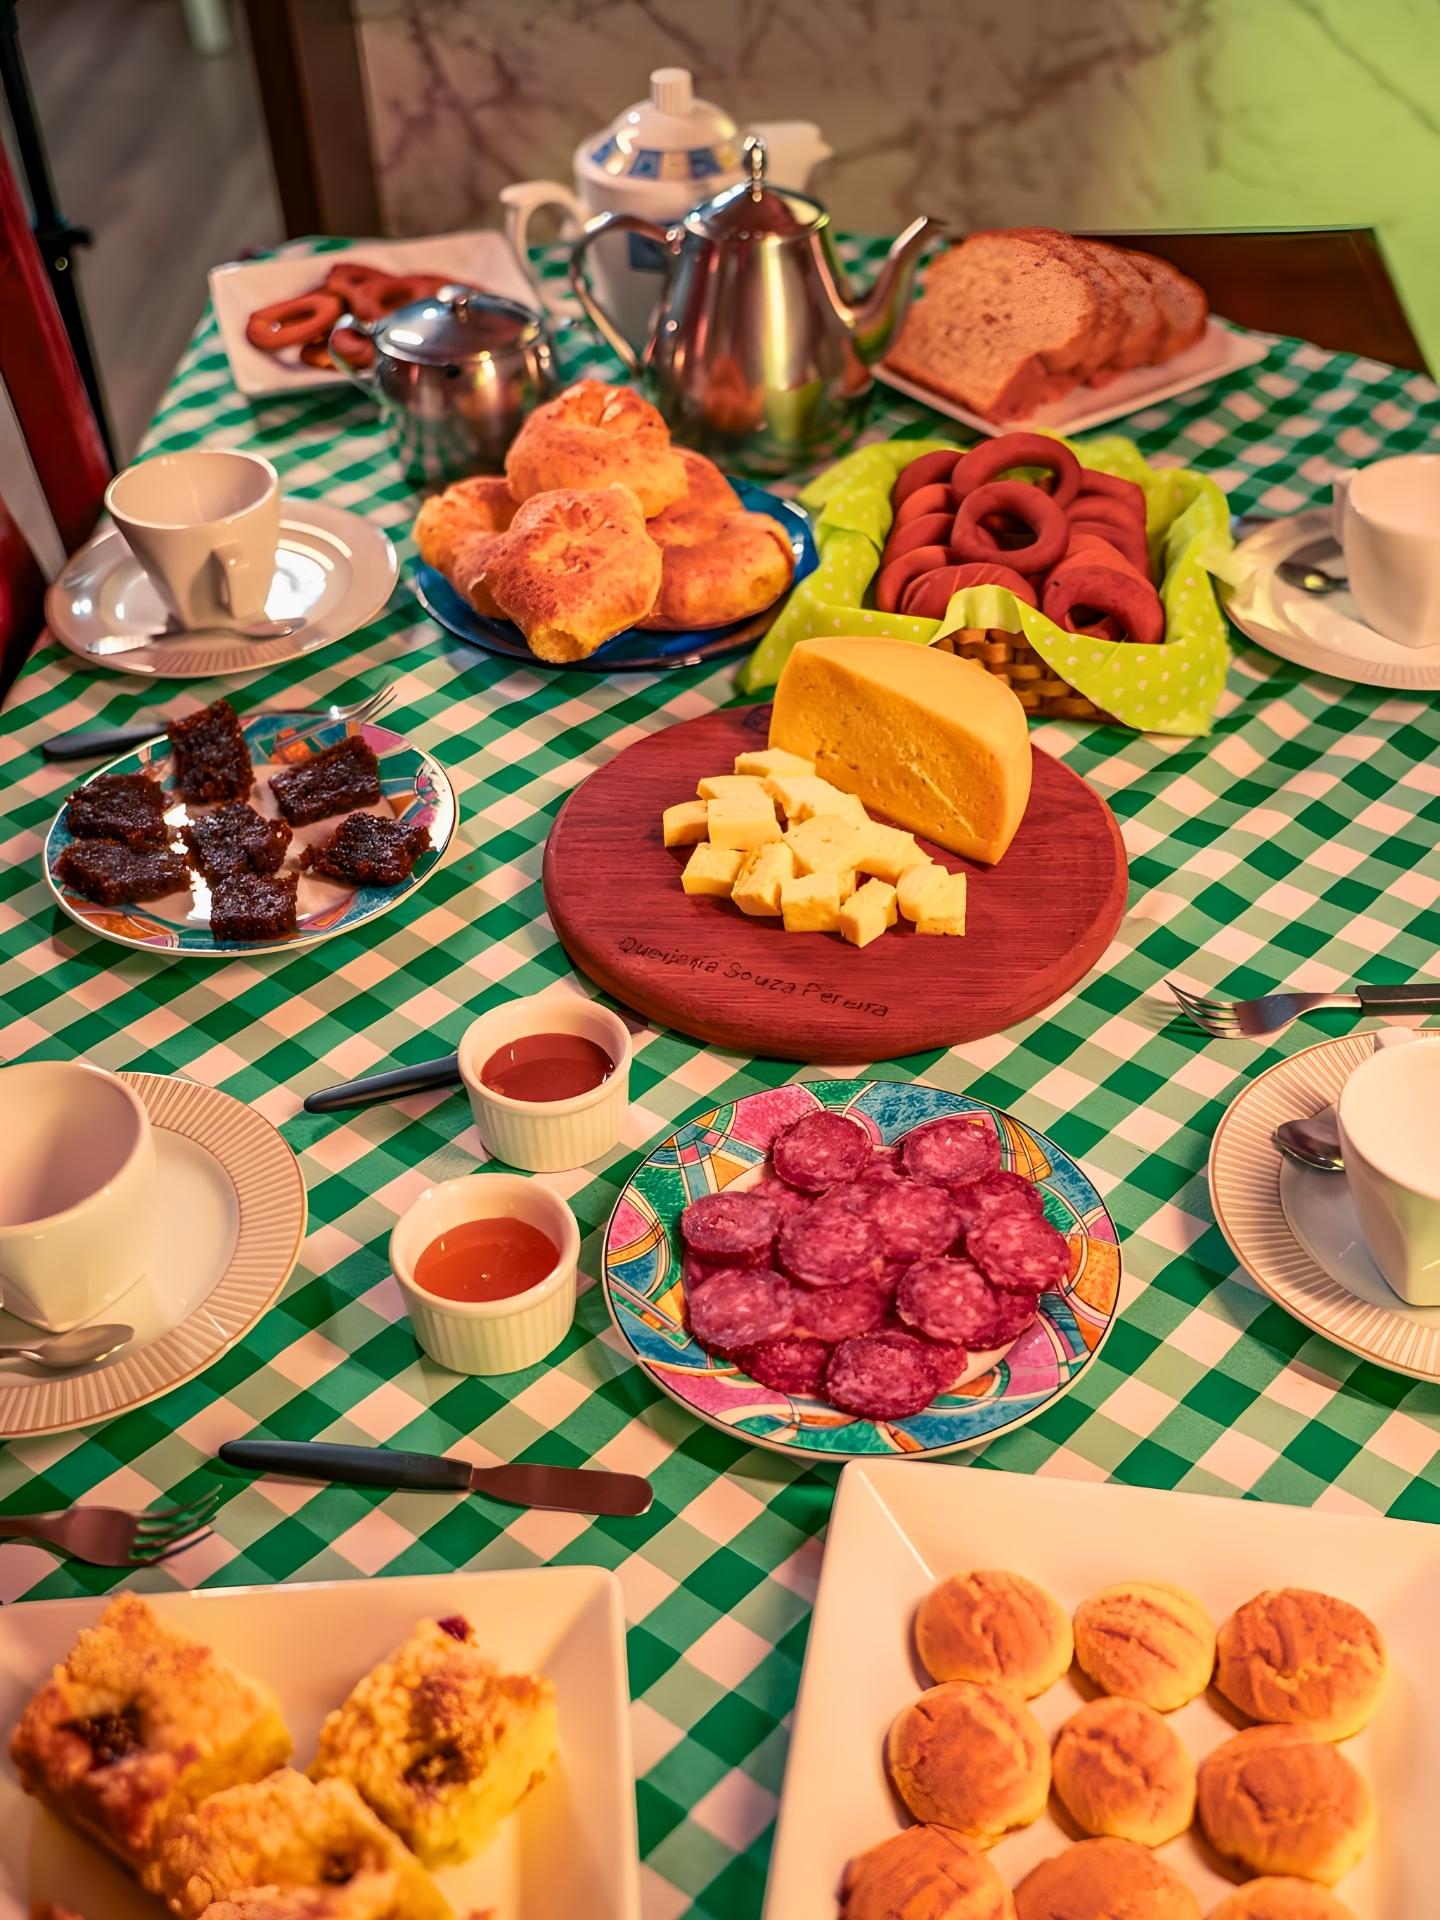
106;447;280;628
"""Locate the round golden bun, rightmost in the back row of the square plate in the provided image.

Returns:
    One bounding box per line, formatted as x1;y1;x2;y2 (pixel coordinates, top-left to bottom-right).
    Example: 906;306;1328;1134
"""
1215;1586;1384;1740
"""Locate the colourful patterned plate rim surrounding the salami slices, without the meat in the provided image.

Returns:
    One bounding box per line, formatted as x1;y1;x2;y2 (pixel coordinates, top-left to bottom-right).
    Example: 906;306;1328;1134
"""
605;1081;1119;1459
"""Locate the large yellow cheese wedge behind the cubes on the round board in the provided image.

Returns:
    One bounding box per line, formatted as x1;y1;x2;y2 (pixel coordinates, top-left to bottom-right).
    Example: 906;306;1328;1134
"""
770;639;1031;864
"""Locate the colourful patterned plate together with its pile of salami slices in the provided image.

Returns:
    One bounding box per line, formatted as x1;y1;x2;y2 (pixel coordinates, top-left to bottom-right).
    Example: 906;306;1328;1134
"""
603;1081;1119;1459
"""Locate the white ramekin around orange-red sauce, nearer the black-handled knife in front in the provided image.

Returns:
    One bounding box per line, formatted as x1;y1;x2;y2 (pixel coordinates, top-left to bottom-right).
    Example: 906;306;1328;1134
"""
390;1173;580;1373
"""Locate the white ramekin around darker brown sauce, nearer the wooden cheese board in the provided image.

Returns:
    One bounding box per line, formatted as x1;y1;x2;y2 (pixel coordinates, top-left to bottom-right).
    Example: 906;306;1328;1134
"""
461;993;632;1173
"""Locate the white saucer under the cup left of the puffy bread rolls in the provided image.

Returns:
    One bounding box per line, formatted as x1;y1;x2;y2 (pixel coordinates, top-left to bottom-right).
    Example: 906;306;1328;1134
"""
44;495;397;680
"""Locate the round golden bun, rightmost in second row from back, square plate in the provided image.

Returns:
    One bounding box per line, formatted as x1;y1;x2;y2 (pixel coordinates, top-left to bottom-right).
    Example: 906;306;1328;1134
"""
1198;1726;1375;1887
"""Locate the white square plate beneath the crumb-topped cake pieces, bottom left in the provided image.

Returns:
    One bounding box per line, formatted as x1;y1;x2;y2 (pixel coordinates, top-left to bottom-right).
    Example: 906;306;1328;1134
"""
0;1567;639;1920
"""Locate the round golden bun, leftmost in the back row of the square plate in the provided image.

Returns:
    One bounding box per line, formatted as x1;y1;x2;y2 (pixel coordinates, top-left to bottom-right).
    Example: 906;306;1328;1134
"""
916;1569;1075;1699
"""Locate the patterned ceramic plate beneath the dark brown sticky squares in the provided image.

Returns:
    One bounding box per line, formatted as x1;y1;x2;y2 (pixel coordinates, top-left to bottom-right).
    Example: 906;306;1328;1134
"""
44;710;455;960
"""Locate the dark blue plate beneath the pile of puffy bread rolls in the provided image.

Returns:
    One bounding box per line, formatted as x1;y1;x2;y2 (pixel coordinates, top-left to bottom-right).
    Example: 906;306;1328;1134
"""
413;478;818;674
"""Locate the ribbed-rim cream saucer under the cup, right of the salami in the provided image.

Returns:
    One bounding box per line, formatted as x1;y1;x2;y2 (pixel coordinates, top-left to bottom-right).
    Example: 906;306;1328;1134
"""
1210;1029;1440;1380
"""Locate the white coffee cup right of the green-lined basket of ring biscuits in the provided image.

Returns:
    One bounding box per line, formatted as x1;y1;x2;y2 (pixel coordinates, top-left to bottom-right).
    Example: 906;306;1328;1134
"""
1334;453;1440;647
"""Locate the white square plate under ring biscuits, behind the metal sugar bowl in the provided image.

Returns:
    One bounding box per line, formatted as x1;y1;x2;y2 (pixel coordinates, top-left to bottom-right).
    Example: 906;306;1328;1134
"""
209;232;538;399
